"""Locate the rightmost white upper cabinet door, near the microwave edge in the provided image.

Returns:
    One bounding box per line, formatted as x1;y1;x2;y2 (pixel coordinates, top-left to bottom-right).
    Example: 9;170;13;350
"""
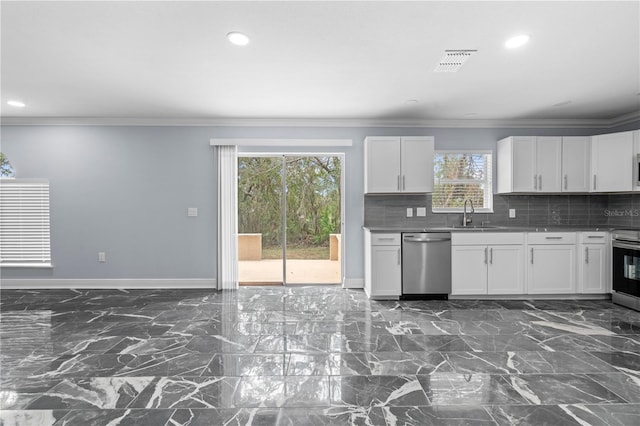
590;132;633;192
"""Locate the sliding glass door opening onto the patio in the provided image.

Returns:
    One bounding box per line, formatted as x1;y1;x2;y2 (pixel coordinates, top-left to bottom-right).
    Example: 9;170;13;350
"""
238;154;343;285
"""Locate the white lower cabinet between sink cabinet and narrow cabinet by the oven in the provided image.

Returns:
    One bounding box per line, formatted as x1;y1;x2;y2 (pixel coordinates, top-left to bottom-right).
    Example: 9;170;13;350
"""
527;232;577;294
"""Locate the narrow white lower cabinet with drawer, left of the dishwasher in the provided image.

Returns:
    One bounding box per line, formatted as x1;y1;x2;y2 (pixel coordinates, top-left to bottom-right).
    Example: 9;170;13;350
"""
364;230;402;299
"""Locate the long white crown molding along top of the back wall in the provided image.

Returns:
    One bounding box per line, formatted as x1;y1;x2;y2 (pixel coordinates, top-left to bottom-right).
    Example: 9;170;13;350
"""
0;111;640;129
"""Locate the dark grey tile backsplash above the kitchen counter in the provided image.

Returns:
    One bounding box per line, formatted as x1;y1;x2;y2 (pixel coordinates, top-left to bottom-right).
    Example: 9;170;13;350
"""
364;193;640;228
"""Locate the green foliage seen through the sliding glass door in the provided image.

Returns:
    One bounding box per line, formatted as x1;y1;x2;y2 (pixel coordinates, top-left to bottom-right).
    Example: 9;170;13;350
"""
238;156;341;247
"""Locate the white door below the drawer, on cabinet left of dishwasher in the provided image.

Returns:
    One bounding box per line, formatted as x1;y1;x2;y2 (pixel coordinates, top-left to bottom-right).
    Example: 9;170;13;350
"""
371;246;402;297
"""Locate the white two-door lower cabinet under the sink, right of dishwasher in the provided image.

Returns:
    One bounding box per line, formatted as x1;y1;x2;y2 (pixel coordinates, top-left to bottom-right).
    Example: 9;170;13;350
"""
451;232;525;296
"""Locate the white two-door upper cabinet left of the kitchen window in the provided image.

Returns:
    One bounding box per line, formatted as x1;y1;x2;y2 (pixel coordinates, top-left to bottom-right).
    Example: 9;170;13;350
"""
364;136;434;194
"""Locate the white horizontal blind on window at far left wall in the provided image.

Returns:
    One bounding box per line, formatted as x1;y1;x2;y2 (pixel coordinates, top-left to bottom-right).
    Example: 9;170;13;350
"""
0;179;51;267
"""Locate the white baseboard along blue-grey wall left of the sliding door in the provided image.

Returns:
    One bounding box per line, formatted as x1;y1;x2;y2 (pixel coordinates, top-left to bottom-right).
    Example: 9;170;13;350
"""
0;278;218;290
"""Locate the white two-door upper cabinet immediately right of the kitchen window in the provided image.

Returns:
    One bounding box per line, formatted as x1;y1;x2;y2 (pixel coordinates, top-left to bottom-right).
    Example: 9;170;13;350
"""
498;136;562;193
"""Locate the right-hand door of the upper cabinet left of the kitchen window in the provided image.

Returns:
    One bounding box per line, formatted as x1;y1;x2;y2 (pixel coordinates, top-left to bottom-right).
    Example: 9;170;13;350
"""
400;137;434;192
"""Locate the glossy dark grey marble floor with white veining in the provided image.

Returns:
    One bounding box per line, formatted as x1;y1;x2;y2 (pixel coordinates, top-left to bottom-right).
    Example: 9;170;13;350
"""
0;286;640;426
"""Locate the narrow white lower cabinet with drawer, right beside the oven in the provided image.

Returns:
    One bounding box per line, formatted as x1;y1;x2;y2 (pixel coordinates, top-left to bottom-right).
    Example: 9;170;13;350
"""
578;232;611;294
